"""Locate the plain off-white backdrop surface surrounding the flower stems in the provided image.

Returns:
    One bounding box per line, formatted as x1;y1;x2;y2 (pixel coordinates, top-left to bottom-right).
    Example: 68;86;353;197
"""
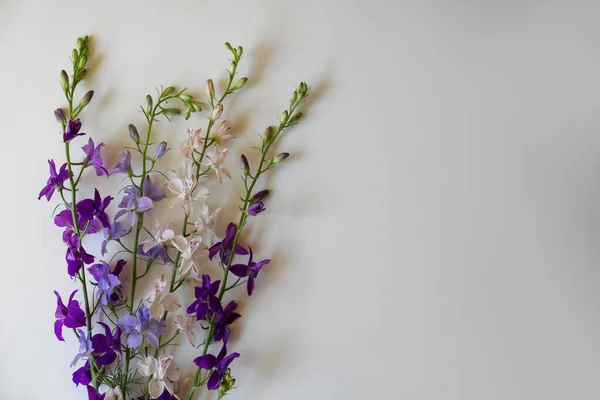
0;0;600;400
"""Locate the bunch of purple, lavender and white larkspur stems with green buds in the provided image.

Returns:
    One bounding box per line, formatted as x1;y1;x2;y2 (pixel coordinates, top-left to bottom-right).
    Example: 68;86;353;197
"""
39;36;308;400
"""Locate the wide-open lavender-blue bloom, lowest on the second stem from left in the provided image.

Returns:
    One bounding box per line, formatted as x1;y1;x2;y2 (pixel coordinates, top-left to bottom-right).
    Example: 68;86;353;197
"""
117;304;167;348
